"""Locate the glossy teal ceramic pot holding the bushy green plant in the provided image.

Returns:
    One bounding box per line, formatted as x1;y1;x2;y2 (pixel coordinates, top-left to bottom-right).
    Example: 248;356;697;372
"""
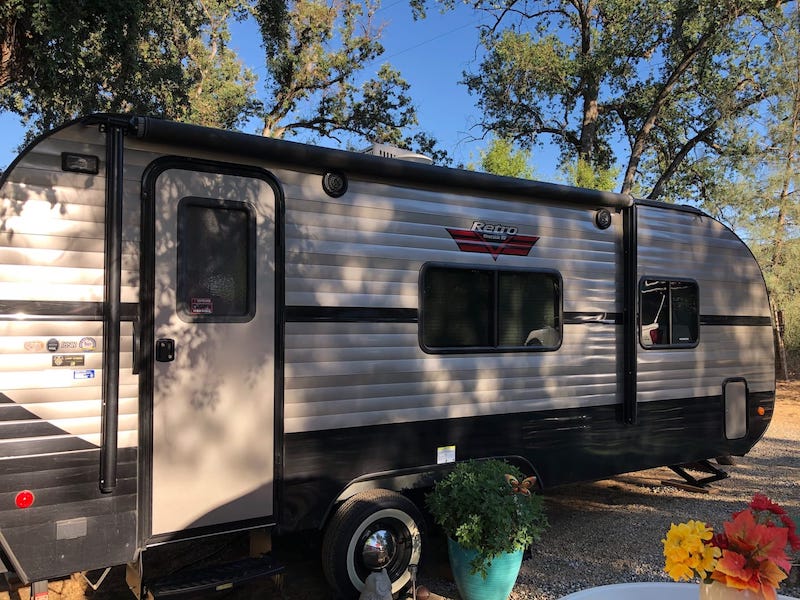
447;538;522;600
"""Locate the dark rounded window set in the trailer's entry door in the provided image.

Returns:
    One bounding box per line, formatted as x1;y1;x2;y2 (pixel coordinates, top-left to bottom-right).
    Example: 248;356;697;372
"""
177;198;255;322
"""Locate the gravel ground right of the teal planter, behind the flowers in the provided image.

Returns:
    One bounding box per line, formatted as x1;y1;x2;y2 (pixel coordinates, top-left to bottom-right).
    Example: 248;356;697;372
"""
488;384;800;600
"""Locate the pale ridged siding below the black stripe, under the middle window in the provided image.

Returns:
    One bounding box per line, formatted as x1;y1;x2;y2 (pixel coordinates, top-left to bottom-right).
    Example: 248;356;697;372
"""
285;323;619;432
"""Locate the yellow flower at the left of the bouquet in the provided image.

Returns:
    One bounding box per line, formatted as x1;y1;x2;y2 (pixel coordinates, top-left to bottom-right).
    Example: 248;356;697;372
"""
661;520;720;581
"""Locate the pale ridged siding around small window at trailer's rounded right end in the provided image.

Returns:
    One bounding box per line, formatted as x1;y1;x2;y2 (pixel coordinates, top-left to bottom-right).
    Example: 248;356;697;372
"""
637;206;774;402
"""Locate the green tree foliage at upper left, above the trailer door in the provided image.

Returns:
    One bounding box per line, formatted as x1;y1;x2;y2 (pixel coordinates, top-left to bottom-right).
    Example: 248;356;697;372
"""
0;0;447;162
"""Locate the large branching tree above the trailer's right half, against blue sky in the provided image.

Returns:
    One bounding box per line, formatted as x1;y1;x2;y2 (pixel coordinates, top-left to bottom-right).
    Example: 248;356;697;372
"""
412;0;785;199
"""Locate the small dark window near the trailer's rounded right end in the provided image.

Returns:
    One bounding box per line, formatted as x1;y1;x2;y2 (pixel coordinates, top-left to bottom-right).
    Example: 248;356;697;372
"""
639;279;699;348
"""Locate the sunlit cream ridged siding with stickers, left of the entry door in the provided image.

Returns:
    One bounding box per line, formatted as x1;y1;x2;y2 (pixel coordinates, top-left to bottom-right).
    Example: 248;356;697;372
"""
0;126;139;460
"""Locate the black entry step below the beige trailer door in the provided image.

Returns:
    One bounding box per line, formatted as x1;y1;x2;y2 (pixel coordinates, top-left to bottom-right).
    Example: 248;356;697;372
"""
145;555;285;598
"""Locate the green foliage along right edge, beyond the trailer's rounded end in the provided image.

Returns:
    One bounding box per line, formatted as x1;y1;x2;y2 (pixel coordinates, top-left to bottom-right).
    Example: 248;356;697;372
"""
700;3;800;370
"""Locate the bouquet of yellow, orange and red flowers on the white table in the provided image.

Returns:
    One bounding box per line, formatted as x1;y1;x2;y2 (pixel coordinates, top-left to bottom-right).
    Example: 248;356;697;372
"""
662;494;800;600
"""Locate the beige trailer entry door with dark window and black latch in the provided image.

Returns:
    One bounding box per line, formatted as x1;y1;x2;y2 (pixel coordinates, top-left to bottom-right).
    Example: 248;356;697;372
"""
150;163;277;538
